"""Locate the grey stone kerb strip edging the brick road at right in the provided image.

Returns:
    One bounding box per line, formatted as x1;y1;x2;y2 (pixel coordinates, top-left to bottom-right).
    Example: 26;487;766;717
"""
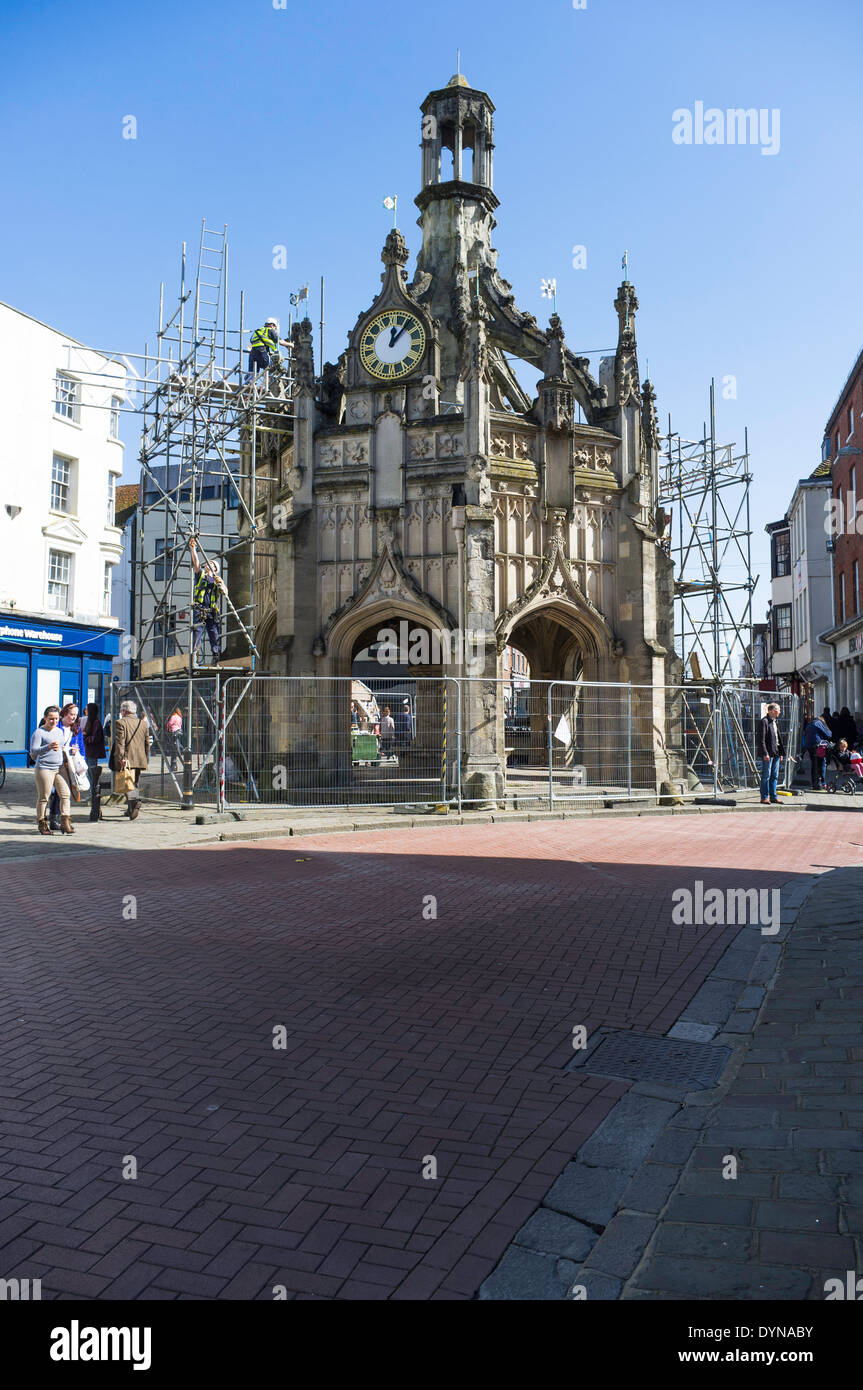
477;874;820;1301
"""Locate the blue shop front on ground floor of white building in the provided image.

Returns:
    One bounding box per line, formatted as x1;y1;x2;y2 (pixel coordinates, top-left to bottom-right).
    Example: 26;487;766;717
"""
0;613;121;767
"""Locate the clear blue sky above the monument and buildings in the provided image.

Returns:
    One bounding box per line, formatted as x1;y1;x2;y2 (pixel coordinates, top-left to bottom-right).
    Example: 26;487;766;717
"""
0;0;863;597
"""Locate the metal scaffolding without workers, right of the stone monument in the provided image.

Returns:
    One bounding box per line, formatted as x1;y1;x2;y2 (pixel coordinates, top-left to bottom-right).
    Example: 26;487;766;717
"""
657;381;757;681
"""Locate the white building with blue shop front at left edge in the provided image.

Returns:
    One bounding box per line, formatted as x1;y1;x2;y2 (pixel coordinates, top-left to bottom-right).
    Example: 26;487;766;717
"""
0;303;126;766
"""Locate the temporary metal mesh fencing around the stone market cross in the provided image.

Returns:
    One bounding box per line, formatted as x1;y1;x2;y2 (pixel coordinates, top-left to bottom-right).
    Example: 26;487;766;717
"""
113;671;799;810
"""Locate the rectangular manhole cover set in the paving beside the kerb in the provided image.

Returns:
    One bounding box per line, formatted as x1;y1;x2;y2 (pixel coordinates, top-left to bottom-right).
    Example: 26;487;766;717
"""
568;1033;731;1091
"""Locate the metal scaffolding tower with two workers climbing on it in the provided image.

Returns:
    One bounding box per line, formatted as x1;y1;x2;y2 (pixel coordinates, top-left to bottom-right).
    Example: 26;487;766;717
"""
64;220;300;805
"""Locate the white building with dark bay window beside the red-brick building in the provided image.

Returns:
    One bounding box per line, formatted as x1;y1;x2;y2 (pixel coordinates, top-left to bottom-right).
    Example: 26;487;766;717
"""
766;464;832;710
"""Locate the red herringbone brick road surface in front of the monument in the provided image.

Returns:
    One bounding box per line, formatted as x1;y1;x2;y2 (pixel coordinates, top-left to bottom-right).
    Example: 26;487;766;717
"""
0;810;863;1300
